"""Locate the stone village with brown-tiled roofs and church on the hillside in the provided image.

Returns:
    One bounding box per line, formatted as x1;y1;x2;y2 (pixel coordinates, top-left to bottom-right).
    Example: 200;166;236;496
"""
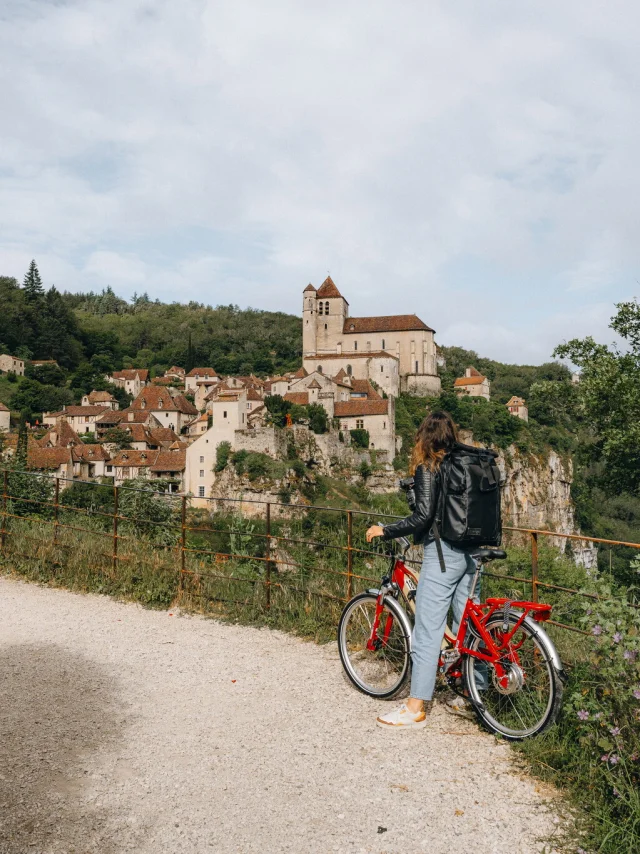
0;277;527;505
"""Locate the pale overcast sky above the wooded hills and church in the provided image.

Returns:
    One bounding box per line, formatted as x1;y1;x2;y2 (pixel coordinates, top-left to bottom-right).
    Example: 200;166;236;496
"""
0;0;640;362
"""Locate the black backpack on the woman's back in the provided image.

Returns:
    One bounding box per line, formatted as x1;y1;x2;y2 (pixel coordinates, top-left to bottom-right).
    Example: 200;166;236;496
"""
433;443;502;552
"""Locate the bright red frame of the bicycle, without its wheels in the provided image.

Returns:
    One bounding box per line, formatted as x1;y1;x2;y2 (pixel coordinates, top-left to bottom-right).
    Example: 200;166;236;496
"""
367;544;551;688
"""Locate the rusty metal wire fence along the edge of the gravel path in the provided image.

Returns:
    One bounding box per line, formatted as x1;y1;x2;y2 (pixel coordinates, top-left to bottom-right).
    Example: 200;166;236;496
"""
0;469;640;633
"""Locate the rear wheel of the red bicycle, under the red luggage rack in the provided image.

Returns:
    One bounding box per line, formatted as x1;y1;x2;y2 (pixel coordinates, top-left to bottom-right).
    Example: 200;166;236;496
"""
463;613;562;741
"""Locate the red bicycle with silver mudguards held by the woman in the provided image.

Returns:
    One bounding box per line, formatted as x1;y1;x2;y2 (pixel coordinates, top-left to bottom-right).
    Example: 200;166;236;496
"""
338;538;565;741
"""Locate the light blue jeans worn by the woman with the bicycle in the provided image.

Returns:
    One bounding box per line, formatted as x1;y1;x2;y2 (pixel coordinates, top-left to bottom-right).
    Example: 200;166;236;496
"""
411;540;481;700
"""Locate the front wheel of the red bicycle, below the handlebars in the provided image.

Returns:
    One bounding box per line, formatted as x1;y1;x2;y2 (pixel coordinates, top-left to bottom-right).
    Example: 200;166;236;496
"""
338;593;411;699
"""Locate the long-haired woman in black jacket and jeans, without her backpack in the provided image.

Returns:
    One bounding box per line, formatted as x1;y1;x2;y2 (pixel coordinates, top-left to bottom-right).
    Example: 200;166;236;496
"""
367;412;475;729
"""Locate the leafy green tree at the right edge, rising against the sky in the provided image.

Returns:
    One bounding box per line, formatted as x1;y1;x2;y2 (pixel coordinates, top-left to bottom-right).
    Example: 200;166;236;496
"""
554;300;640;492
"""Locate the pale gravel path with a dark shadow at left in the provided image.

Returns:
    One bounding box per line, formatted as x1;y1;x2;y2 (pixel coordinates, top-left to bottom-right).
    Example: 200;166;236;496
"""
0;578;558;854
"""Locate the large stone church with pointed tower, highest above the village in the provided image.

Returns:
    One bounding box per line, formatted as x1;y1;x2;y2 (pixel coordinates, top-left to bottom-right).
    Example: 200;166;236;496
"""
302;276;440;396
